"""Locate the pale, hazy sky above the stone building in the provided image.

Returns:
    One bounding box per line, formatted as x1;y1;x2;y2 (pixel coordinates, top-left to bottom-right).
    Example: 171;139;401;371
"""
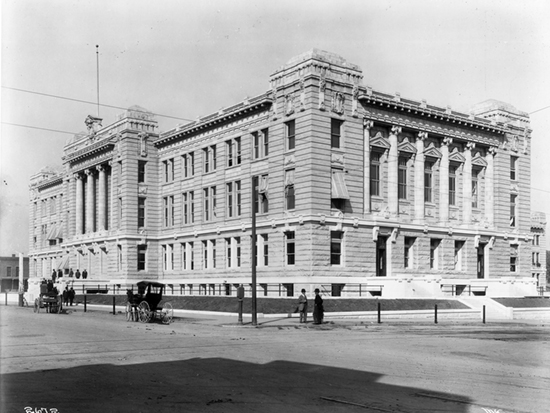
0;0;550;256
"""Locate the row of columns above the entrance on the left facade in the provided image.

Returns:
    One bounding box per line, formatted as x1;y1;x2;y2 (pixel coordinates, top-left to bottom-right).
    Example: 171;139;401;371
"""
75;165;107;235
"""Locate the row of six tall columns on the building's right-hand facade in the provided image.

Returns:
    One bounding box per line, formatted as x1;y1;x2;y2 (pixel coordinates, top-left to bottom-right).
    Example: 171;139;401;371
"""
363;119;496;223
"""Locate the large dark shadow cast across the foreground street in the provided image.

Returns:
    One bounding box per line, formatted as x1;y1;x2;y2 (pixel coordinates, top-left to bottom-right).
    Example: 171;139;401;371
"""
0;358;474;413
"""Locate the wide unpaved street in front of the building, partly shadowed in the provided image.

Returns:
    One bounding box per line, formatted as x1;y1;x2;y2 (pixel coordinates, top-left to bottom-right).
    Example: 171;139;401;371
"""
0;306;550;413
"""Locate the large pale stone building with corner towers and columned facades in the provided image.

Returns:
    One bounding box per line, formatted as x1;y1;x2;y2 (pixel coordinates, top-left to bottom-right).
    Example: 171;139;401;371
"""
30;50;544;297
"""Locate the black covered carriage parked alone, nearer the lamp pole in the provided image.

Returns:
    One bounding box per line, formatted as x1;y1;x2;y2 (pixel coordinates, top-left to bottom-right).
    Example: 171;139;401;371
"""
126;281;174;324
